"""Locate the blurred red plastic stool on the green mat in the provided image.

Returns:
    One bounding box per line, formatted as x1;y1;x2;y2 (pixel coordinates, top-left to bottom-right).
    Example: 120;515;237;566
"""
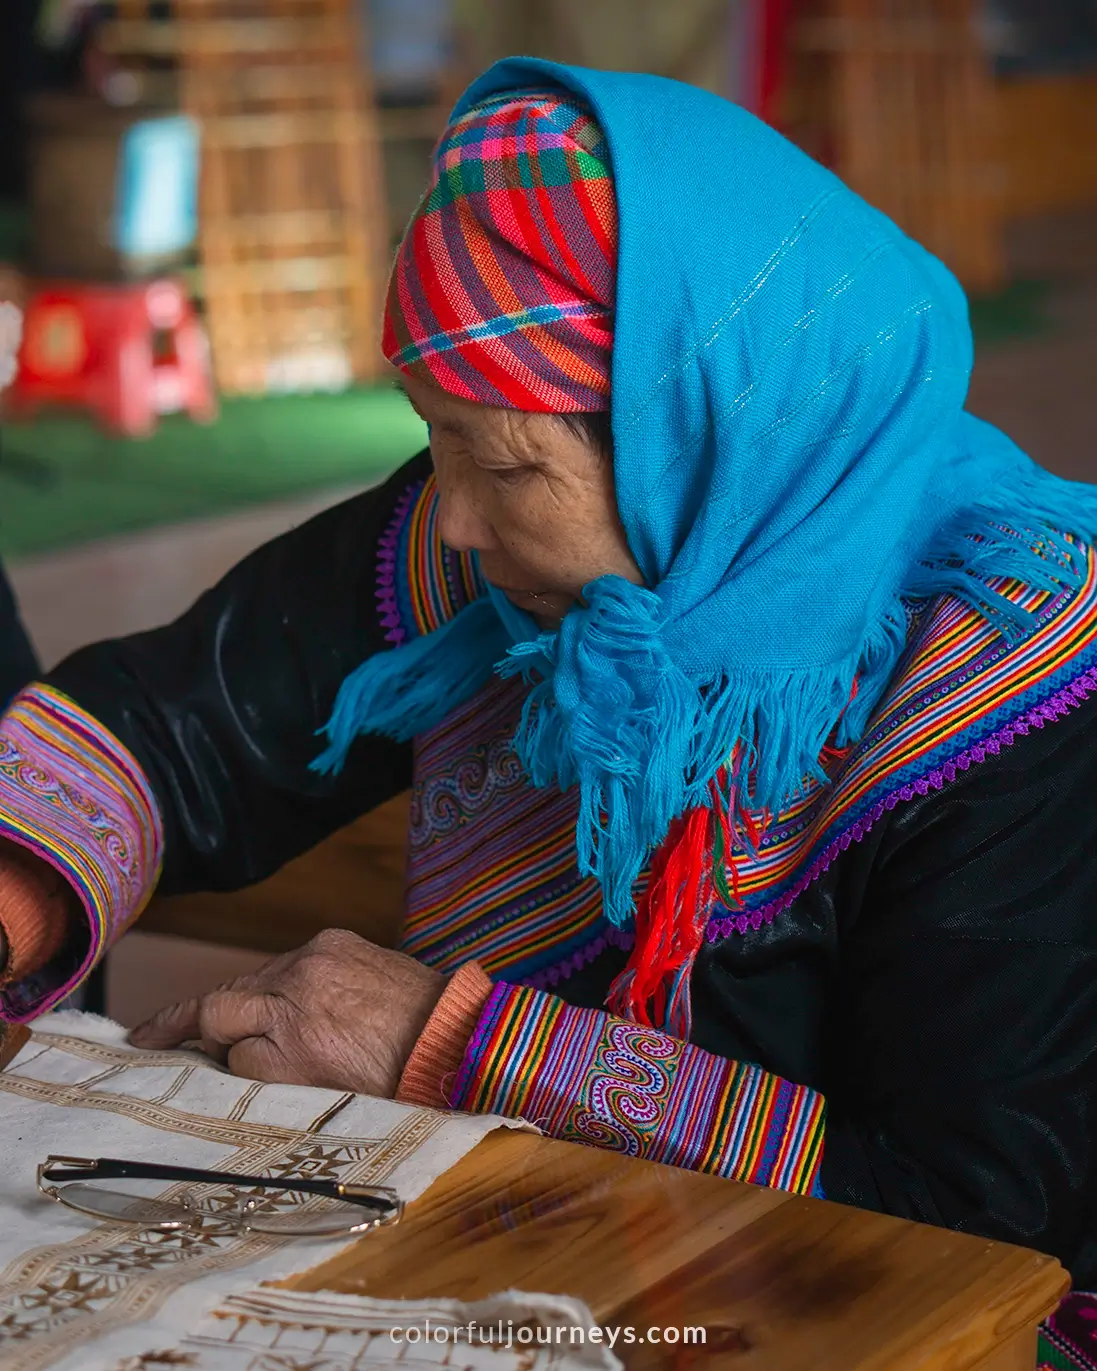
8;281;217;437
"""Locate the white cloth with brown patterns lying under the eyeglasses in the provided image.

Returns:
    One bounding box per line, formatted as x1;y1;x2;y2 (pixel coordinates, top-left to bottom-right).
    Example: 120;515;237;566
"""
0;1013;532;1371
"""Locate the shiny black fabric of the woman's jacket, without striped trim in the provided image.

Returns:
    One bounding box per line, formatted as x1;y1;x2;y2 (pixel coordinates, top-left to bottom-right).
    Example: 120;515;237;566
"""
49;454;1097;1286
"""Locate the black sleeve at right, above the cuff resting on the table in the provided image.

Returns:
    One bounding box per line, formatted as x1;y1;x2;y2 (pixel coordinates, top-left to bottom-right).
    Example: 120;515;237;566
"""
823;699;1097;1283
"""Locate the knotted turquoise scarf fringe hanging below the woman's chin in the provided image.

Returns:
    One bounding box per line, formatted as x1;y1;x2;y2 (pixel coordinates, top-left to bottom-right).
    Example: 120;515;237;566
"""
499;577;906;928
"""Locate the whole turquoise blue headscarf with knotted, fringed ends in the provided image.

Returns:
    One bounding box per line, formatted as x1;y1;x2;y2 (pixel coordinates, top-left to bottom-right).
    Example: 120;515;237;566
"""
317;59;1097;924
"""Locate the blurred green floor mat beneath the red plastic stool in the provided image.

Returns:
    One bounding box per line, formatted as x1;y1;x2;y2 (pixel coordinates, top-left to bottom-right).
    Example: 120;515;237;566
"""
0;387;426;557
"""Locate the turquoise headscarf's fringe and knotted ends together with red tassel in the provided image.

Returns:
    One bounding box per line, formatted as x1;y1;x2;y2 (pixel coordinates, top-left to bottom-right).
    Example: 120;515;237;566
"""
313;468;1097;1023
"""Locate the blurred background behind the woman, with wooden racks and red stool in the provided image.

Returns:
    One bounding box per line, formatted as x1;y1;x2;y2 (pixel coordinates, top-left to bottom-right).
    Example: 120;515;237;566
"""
0;0;1097;1020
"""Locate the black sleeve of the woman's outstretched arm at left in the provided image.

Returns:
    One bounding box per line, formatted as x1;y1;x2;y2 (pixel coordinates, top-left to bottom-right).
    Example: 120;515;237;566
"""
47;454;431;894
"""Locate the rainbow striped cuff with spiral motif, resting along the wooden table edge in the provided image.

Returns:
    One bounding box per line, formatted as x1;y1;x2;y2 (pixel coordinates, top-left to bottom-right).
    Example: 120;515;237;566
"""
453;984;825;1196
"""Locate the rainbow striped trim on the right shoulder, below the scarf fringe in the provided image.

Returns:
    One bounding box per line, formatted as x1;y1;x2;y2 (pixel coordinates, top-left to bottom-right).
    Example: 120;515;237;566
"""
706;548;1097;942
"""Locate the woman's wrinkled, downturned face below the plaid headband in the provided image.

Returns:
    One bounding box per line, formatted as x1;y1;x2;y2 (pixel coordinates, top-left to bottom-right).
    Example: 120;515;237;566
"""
402;376;643;625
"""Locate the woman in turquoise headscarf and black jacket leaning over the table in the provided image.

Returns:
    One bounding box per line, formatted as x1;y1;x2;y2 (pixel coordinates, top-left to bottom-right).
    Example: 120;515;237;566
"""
0;60;1097;1360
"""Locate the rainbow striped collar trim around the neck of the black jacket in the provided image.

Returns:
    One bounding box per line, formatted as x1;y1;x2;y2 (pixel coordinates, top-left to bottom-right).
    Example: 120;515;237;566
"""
397;481;1097;988
